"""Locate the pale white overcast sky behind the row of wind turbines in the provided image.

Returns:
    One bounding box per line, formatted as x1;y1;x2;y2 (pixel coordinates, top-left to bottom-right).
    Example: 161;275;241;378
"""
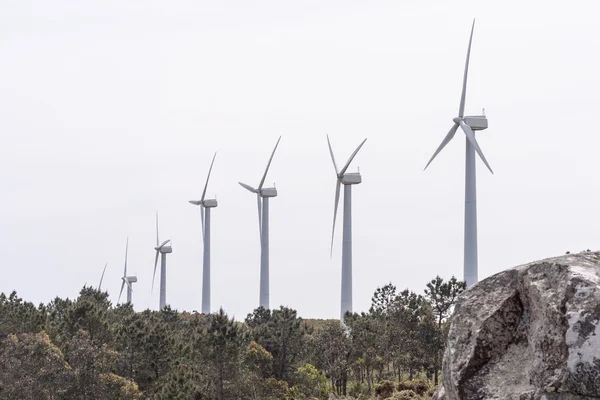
0;0;600;318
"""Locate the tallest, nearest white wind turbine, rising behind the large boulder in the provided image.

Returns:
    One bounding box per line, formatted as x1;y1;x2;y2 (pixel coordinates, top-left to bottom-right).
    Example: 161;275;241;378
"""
425;20;494;287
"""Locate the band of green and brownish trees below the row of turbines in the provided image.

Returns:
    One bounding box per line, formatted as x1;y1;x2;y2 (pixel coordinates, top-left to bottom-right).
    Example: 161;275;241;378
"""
0;277;465;400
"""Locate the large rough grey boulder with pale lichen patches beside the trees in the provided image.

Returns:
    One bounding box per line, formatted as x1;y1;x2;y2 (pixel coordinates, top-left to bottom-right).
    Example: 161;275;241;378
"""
434;252;600;400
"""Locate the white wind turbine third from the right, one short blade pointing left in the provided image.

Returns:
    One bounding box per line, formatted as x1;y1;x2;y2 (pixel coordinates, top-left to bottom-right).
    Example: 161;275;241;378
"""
239;136;281;308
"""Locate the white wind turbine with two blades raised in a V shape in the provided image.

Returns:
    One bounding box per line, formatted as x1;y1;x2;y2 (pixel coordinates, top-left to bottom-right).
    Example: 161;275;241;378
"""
327;135;367;322
